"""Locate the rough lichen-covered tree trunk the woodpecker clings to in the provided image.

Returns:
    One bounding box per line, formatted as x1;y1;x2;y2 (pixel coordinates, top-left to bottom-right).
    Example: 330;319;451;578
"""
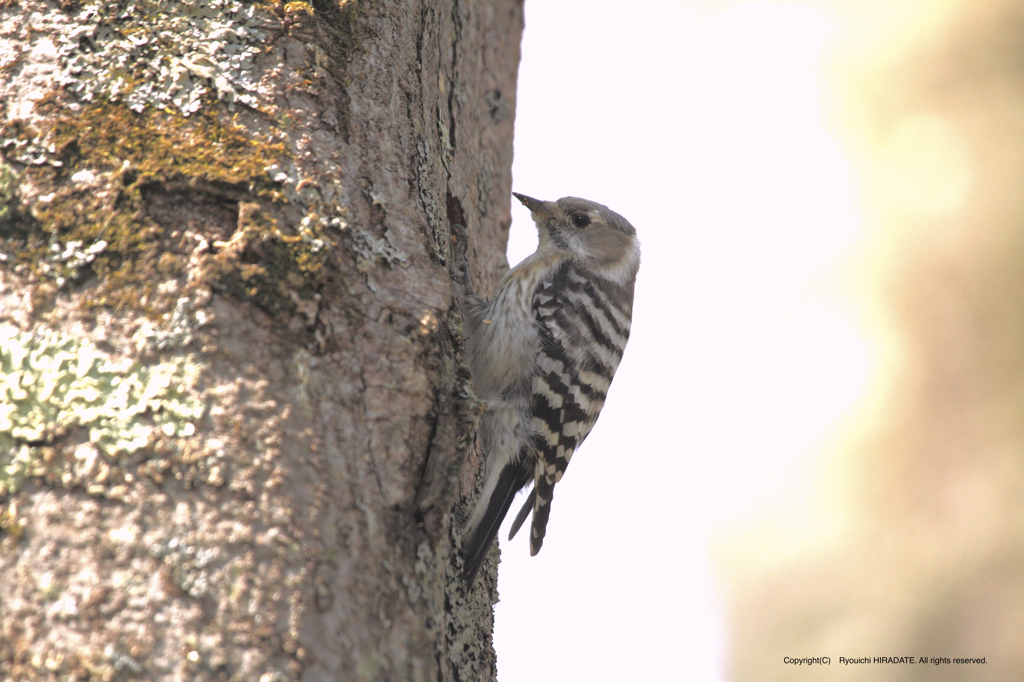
0;0;522;682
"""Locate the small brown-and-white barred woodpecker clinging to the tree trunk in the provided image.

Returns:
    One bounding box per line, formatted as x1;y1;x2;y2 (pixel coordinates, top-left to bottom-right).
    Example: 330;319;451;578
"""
459;193;640;585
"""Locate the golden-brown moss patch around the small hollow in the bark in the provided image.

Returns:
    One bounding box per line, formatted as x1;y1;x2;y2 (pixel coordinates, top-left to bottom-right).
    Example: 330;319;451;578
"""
0;102;331;316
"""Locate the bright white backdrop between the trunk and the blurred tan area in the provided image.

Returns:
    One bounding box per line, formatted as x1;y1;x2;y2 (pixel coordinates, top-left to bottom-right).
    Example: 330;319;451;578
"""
495;0;871;682
